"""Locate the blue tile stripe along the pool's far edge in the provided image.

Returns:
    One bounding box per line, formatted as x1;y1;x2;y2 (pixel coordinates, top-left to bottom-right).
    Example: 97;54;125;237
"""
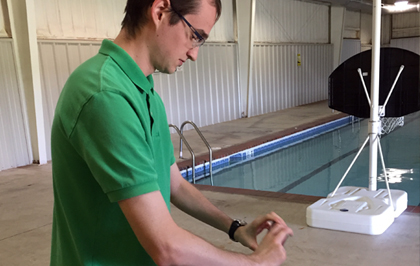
181;116;357;182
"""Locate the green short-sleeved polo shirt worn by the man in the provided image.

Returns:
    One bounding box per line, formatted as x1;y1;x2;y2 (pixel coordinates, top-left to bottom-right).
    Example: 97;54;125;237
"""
51;40;175;266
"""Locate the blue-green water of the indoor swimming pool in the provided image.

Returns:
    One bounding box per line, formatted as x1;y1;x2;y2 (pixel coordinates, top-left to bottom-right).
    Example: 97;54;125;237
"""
197;112;420;206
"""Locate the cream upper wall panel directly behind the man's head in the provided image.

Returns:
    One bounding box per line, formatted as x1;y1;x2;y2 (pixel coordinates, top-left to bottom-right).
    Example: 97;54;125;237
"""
35;0;235;41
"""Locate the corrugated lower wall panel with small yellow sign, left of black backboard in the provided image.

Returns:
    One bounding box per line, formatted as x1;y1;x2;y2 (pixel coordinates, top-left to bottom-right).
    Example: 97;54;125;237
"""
249;44;333;116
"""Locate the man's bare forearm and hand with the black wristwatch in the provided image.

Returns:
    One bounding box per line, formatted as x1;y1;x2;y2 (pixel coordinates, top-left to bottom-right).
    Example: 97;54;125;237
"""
171;163;287;250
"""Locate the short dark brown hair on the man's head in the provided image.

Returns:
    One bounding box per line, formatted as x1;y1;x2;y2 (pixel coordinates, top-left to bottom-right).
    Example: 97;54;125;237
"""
121;0;222;37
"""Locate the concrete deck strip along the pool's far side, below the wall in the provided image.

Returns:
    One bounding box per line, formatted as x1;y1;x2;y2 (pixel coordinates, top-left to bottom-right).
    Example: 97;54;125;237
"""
171;101;347;169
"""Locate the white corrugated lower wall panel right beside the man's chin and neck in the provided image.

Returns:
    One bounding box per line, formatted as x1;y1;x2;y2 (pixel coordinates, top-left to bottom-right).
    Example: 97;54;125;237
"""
154;44;240;127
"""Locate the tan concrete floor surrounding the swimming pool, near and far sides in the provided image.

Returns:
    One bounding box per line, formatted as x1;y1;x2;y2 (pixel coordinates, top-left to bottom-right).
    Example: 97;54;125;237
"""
0;102;420;266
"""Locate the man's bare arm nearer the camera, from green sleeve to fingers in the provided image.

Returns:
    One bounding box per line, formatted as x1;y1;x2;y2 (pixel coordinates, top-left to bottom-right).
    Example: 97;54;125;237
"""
119;187;292;266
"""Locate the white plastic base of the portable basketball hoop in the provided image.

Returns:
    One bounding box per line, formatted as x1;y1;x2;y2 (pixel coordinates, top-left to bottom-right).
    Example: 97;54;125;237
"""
306;187;407;235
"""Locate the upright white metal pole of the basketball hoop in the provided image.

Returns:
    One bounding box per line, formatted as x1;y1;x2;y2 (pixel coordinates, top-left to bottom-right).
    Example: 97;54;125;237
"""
369;0;381;191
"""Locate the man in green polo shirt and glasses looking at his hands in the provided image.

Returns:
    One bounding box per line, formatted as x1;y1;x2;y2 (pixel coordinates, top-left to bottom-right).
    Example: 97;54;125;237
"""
51;0;293;266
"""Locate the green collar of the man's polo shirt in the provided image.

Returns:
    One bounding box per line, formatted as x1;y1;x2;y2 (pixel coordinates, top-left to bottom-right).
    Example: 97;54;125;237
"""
99;39;154;94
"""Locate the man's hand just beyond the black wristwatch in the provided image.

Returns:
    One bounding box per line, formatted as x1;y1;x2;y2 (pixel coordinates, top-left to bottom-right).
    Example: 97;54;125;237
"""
234;212;293;251
